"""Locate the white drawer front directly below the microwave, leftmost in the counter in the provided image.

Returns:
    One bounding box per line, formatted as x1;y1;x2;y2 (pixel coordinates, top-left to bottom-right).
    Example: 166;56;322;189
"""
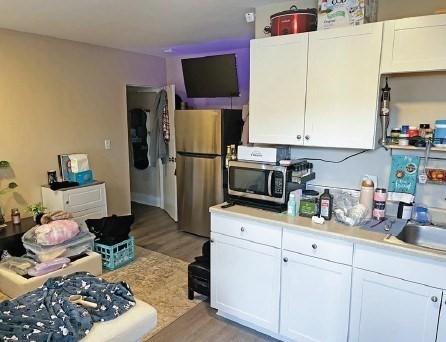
211;214;282;248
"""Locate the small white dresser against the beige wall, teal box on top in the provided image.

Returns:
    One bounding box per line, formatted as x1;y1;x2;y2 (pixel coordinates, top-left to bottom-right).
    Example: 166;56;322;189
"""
42;182;107;223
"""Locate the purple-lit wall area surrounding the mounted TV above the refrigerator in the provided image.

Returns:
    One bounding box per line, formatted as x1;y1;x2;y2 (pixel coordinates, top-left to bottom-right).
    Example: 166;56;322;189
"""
166;48;249;108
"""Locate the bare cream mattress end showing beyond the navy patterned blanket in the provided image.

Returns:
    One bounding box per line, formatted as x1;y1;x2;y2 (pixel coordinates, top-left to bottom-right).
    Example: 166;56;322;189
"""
81;299;157;342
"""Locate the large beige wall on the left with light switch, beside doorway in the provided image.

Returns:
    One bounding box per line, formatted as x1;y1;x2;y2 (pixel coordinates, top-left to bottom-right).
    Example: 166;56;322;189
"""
0;30;166;216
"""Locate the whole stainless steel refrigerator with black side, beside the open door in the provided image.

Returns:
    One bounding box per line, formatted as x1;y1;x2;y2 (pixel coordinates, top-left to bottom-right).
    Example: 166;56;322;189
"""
175;109;243;237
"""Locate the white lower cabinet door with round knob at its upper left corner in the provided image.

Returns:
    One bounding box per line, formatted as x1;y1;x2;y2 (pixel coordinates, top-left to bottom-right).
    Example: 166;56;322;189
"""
280;251;352;342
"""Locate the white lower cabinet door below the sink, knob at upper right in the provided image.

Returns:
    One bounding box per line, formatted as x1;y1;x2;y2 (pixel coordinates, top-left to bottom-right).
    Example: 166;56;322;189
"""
350;269;442;342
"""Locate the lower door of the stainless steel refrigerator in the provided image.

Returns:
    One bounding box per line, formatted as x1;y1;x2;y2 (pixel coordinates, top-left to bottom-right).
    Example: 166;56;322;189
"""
177;153;223;237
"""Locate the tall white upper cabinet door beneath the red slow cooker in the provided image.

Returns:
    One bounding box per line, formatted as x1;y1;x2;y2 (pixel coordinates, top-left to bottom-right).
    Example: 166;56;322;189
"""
249;33;308;145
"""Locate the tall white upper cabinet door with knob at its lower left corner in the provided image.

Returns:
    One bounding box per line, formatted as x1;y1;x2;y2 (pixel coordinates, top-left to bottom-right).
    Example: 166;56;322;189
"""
305;23;382;149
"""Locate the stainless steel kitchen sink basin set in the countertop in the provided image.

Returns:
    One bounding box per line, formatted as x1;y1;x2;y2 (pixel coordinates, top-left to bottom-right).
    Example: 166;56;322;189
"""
395;223;446;251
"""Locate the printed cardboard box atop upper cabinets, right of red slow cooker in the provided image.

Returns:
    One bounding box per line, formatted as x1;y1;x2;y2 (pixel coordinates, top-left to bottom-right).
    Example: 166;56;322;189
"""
317;0;378;30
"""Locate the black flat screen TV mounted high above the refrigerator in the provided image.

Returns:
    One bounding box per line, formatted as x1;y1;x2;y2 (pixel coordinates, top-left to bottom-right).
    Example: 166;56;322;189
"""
181;54;240;98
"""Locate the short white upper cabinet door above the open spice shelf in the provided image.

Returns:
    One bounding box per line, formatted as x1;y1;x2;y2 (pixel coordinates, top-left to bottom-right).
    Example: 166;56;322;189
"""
381;14;446;74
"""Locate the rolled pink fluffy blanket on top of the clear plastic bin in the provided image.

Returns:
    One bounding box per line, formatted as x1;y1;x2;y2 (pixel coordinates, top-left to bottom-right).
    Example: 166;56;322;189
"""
35;220;80;246
